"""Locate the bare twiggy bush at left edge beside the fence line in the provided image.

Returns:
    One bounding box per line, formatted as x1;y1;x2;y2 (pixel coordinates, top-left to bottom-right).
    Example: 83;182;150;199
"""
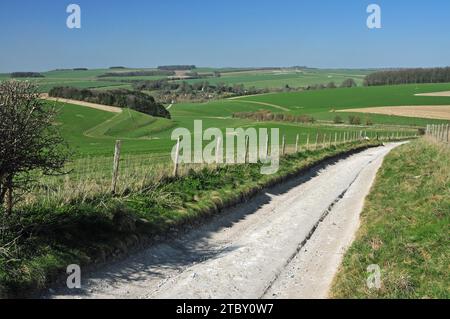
0;80;68;214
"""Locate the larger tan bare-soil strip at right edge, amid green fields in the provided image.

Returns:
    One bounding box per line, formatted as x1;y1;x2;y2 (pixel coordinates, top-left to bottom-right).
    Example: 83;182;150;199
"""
337;105;450;120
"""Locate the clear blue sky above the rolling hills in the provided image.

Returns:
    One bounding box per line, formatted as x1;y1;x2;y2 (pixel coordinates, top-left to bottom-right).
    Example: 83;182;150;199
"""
0;0;450;72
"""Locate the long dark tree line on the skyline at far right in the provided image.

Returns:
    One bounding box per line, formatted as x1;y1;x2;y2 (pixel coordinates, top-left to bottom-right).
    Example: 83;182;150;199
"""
364;67;450;86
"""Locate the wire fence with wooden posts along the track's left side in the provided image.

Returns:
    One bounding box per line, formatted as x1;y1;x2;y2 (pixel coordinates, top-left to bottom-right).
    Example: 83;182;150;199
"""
21;130;417;209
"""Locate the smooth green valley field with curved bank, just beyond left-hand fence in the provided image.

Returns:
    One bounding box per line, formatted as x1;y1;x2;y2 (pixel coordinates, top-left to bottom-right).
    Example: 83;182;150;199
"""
51;101;415;158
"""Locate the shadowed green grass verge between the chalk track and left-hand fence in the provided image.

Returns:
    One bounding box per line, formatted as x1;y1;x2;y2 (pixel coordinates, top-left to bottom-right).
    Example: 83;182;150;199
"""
0;142;378;297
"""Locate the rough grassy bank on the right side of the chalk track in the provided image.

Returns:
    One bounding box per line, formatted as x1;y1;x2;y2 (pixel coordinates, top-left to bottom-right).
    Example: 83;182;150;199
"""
332;140;450;299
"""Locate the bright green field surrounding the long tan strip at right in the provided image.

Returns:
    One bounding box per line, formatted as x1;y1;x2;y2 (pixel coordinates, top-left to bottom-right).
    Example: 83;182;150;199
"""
234;83;450;126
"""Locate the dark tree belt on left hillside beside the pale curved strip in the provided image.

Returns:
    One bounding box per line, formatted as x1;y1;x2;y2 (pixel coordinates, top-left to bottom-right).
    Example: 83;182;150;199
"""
49;87;170;119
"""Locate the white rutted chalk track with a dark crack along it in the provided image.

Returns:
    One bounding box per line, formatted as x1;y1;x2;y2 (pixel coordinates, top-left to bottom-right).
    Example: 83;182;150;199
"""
44;144;404;298
